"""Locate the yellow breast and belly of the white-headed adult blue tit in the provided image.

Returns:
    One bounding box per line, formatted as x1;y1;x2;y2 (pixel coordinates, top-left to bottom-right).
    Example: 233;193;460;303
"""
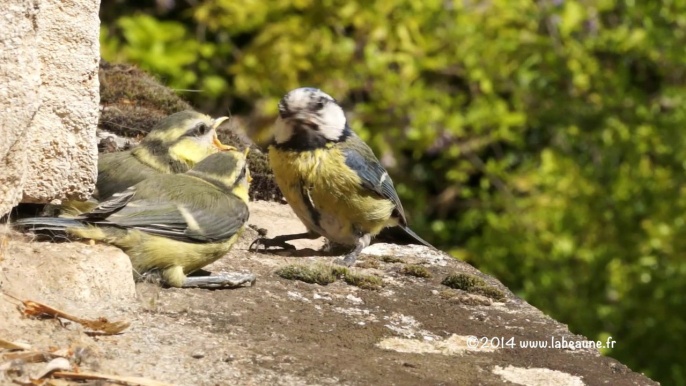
269;146;395;244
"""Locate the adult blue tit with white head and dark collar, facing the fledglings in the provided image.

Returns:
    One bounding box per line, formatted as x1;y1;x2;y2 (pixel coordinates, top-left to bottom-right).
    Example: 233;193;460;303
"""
251;88;433;266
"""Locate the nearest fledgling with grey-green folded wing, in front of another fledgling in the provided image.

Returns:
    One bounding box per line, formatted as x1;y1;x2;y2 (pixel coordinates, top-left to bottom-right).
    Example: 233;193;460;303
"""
14;151;255;288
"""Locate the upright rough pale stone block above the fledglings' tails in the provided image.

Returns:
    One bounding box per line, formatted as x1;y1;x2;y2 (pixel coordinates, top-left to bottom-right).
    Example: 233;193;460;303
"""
0;0;100;216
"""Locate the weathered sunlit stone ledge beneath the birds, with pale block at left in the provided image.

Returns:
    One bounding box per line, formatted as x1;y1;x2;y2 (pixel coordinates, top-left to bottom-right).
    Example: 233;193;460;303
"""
0;202;656;386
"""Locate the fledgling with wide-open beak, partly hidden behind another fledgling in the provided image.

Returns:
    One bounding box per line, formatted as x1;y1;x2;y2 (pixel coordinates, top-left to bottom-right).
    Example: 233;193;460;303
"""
56;110;236;216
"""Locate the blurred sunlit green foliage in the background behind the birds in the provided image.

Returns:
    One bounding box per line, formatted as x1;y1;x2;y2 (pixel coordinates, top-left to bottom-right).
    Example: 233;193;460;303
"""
101;0;686;385
